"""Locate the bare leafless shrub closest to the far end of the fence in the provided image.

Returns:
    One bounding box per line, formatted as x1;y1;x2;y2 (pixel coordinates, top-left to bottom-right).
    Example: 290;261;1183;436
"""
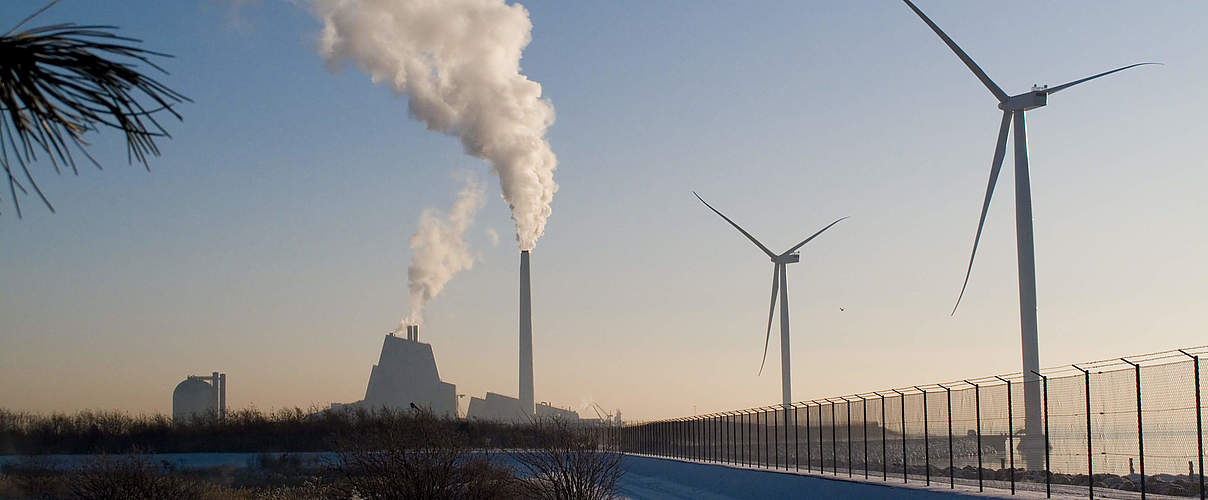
516;418;625;500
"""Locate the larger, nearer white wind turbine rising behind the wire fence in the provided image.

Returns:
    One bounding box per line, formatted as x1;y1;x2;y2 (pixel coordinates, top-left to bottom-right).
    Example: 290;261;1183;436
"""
902;0;1157;466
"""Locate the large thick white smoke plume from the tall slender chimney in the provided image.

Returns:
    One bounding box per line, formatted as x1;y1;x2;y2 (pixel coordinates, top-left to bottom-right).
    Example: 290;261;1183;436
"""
315;0;558;250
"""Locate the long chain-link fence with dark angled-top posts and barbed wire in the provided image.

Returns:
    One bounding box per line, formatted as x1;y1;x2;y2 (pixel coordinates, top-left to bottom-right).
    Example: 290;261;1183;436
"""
617;347;1208;499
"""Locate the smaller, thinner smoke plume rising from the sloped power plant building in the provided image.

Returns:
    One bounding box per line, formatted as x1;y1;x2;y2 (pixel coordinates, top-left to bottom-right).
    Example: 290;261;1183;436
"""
402;175;486;325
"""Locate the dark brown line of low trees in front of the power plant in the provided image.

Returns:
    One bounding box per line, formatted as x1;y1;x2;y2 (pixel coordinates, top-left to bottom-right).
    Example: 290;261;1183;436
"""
0;408;570;454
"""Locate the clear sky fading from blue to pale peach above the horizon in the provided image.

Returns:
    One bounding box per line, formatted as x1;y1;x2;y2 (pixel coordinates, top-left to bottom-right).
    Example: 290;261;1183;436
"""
0;0;1208;418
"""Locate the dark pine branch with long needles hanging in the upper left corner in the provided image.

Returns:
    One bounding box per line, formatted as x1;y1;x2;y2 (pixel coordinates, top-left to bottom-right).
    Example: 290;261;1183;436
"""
0;0;188;217
